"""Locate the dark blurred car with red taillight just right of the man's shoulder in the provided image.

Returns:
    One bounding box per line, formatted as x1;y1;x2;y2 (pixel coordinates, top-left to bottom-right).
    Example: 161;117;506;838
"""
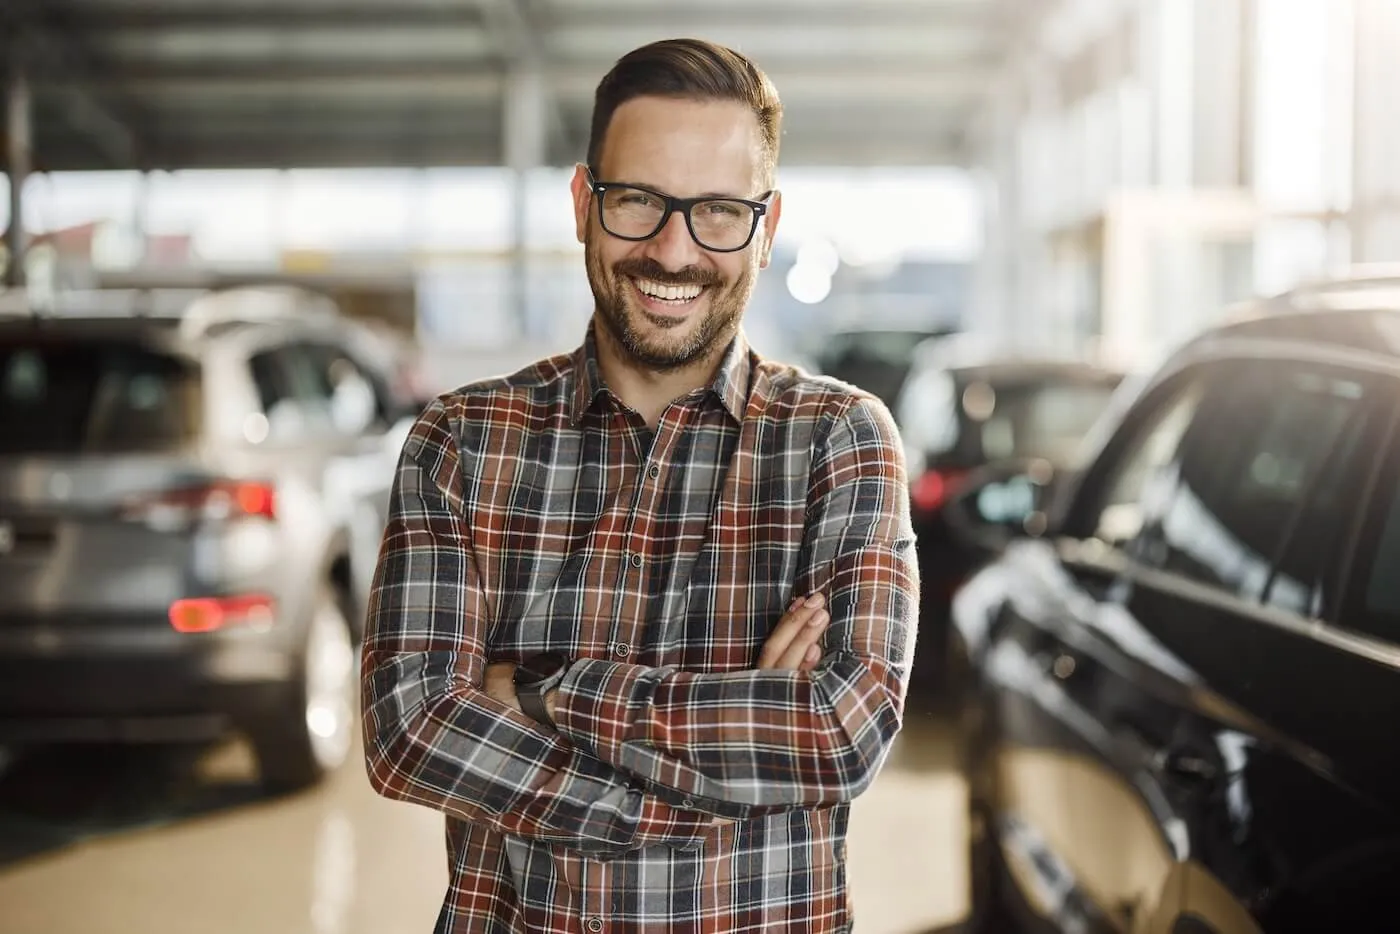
895;335;1123;690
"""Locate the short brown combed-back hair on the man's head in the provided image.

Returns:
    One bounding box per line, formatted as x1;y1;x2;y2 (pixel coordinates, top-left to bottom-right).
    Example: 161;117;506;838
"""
588;39;783;184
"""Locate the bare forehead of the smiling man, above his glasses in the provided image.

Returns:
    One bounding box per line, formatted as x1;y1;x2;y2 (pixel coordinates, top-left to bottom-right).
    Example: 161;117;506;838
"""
595;97;764;197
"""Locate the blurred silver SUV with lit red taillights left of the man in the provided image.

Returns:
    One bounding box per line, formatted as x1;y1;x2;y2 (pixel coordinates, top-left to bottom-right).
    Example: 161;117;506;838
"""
0;288;416;787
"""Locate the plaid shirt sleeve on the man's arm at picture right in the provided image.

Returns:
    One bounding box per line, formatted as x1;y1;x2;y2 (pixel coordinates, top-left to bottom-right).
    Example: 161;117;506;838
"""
556;398;918;816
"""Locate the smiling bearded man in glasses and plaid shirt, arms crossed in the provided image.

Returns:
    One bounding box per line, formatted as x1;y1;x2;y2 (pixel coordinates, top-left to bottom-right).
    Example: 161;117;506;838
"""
363;41;918;934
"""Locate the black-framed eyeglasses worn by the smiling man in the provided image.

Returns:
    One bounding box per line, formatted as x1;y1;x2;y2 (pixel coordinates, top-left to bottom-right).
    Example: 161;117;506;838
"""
585;167;774;253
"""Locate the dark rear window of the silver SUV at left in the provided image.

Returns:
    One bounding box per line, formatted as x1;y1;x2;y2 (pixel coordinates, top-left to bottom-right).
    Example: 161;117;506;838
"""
0;337;199;454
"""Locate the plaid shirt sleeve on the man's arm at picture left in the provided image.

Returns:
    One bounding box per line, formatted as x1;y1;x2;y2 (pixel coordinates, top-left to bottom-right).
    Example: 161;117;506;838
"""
361;400;711;856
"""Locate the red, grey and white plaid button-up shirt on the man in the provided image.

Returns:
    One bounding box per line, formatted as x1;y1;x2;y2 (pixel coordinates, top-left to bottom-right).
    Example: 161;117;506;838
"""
363;324;918;934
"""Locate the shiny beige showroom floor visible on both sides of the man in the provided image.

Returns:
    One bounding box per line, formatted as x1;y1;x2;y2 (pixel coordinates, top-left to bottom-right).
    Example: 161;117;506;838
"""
0;697;966;934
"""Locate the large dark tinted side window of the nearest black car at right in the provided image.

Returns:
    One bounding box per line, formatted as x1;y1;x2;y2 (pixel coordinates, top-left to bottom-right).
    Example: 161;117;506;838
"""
1135;365;1371;615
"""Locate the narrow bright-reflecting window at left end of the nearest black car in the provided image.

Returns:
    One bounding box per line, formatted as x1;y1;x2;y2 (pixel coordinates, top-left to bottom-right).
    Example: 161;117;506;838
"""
1089;377;1203;548
